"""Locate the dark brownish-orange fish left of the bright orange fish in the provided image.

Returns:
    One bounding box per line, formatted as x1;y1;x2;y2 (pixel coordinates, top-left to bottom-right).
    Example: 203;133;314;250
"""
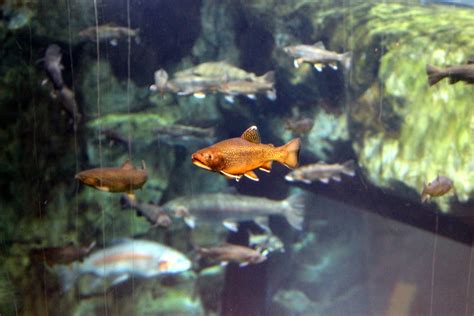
74;160;148;194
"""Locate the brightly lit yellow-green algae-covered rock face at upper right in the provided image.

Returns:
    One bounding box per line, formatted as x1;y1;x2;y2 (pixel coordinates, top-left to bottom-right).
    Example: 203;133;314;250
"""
355;4;474;211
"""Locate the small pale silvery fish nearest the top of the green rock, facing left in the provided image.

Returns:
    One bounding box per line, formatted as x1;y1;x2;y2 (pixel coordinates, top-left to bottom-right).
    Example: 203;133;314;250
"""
283;42;352;71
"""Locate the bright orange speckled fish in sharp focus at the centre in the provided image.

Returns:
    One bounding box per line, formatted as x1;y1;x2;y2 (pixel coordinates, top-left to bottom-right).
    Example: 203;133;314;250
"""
192;126;300;181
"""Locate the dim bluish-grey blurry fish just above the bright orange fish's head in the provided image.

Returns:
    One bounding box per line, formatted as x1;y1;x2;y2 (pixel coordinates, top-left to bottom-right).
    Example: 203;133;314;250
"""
154;124;215;146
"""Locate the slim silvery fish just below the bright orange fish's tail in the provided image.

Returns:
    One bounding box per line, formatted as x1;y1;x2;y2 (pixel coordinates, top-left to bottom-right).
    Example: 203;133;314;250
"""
285;160;355;184
